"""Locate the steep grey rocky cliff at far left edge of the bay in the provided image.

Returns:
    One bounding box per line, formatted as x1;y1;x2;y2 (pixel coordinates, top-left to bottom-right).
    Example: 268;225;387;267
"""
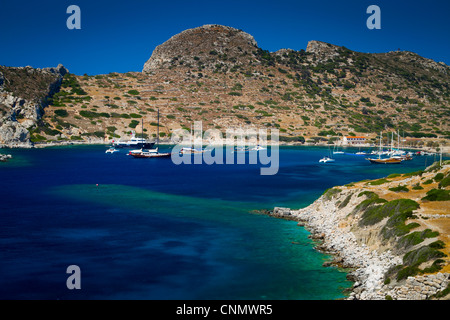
0;65;68;147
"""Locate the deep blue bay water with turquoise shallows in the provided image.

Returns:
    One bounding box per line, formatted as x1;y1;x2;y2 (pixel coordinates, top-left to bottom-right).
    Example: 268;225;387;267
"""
0;146;442;300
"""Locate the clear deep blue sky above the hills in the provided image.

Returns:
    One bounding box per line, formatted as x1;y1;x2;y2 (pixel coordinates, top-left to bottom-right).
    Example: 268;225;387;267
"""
0;0;450;75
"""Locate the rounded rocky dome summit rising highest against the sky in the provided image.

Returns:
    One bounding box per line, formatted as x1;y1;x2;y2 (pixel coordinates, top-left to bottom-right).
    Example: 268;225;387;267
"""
142;25;257;73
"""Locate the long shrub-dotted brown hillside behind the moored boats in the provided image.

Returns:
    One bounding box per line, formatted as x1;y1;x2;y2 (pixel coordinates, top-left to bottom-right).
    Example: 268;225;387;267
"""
0;25;450;146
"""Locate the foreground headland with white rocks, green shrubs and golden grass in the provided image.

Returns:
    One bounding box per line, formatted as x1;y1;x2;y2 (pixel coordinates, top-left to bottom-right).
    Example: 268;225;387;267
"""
271;161;450;300
